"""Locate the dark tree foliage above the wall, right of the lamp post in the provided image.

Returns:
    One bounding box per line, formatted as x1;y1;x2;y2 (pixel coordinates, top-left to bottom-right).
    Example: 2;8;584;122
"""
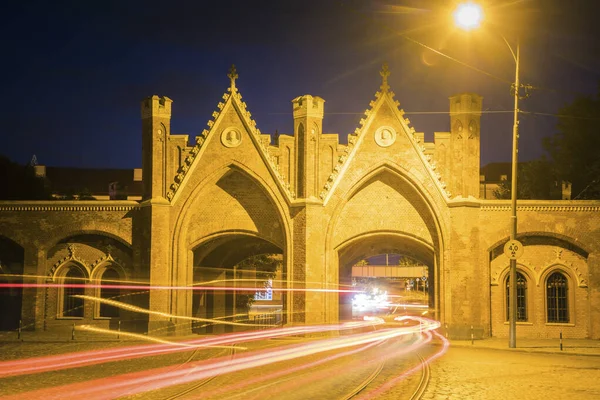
544;90;600;199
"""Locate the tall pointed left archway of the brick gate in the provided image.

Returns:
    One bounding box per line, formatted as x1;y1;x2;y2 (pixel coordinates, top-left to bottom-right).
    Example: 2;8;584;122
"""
174;165;289;333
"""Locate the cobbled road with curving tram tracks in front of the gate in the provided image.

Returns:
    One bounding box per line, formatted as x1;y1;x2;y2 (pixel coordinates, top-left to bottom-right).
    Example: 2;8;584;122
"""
0;326;600;400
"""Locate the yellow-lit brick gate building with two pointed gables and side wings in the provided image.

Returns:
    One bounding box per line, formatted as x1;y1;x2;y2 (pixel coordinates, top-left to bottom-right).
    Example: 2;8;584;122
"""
0;66;600;339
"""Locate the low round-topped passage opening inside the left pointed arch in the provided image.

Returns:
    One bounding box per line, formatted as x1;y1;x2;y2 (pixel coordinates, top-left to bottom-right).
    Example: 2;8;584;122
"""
192;232;287;333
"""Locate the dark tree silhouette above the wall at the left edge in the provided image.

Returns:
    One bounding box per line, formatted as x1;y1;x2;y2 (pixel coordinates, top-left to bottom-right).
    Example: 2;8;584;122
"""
0;155;52;200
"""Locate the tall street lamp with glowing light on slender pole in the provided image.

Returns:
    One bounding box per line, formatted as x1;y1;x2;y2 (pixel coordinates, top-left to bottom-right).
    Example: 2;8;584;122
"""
454;2;519;348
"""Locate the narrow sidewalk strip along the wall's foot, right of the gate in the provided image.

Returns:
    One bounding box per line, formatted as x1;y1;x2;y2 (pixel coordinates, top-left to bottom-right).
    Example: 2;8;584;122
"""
450;337;600;356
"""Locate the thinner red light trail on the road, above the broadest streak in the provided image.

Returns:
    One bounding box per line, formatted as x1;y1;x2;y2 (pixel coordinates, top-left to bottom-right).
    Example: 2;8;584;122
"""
0;321;384;378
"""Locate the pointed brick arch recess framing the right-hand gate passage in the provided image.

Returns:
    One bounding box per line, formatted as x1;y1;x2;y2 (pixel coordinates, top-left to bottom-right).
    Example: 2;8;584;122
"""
331;166;444;320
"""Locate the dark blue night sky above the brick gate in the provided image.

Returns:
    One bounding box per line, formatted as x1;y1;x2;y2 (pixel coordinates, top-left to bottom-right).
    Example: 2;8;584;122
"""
0;0;600;168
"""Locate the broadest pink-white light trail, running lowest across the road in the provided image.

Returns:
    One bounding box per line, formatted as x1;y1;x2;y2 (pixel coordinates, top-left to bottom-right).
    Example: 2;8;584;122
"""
0;318;440;400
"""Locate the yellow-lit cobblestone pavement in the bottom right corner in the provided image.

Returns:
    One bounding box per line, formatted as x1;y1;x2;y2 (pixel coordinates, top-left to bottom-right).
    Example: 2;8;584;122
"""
423;346;600;400
